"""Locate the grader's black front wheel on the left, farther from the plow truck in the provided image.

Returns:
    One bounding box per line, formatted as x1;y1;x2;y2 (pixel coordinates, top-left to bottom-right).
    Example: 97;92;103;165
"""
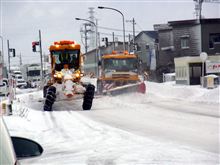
44;86;56;111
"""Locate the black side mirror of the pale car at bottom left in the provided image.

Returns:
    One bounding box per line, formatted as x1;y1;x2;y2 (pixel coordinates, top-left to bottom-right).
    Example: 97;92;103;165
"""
11;137;43;158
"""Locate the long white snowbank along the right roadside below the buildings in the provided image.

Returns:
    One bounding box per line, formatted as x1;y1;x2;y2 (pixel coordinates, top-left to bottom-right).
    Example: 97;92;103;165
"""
146;82;219;103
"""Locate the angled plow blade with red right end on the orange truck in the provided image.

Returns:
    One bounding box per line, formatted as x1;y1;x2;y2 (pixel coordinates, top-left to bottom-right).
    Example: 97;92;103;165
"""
103;82;146;96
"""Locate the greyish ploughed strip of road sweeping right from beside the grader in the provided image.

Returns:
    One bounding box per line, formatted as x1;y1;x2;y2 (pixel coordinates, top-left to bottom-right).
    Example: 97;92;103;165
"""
79;94;219;153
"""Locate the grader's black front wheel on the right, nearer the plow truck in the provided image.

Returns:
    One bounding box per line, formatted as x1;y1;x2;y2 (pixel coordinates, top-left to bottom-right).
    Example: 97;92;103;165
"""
82;84;95;110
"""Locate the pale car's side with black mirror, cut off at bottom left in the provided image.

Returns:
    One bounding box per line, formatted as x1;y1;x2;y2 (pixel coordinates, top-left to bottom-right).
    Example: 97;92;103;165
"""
0;116;43;165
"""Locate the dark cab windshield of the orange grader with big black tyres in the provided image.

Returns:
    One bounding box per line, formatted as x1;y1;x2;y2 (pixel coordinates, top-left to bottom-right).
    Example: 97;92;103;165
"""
51;50;80;70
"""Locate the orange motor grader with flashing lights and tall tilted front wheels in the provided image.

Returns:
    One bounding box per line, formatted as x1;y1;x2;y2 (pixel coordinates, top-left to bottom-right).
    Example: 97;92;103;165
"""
43;40;95;111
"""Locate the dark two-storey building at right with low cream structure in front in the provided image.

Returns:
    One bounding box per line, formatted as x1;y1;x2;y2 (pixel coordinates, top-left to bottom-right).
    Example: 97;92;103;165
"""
154;18;220;85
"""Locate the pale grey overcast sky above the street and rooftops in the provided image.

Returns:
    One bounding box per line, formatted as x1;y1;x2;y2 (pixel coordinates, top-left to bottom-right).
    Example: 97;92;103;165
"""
0;0;220;64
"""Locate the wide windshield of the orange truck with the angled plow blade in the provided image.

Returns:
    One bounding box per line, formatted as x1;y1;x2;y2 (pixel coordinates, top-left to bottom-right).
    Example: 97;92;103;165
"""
104;58;138;72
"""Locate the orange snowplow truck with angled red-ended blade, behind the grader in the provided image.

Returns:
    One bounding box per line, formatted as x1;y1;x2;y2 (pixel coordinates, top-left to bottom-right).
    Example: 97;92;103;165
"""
97;51;146;95
